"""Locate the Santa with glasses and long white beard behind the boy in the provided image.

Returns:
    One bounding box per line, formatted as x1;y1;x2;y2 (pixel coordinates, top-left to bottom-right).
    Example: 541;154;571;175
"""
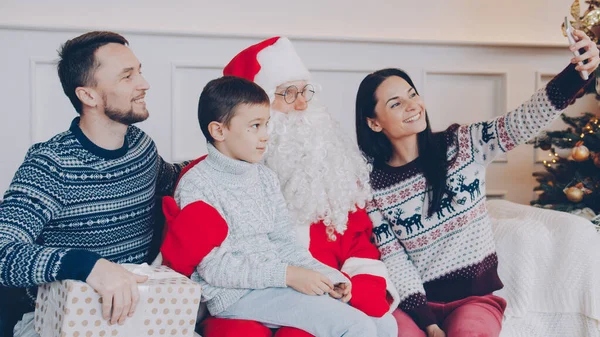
162;37;399;337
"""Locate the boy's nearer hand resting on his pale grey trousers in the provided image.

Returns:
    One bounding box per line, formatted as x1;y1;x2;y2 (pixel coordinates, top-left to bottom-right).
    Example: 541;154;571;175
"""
285;266;334;295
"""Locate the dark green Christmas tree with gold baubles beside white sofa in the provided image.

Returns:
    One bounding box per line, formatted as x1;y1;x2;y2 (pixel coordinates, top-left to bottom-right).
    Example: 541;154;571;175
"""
531;73;600;226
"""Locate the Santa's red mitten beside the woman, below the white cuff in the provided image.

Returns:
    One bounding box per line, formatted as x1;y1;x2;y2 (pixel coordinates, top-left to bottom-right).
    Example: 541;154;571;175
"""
350;274;390;317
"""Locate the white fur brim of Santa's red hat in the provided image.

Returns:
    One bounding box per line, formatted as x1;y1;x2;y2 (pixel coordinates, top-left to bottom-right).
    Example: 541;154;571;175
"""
254;37;310;93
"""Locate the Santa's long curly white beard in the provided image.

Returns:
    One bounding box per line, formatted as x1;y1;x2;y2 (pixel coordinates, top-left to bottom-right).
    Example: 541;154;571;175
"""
265;102;371;234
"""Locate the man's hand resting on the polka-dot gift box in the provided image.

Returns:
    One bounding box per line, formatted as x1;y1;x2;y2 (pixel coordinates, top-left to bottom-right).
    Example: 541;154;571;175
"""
85;259;148;324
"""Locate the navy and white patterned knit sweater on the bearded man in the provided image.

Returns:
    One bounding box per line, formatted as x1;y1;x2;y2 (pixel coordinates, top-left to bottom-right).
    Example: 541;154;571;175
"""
0;118;183;302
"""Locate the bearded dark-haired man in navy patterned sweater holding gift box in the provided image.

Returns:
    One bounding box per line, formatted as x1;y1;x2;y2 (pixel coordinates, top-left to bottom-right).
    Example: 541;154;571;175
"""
0;32;182;336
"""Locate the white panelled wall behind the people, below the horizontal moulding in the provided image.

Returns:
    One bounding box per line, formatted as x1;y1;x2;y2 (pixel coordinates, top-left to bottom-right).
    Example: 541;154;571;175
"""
0;28;597;203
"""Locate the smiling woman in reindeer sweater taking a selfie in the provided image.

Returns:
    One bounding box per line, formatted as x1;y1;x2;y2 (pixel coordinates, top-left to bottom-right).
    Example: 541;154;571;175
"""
356;31;600;337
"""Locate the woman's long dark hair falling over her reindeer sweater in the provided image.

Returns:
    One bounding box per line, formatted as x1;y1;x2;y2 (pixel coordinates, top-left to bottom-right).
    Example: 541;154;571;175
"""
356;68;448;217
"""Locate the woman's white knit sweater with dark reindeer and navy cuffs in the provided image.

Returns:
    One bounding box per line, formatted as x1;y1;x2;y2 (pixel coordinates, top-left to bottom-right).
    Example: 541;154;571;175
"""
368;62;585;328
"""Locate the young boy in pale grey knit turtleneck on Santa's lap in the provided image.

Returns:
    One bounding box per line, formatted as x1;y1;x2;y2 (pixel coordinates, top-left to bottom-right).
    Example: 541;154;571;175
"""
163;76;397;337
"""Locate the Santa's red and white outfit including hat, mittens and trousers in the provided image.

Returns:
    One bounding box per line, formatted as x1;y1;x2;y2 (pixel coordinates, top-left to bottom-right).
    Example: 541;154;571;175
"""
161;37;399;337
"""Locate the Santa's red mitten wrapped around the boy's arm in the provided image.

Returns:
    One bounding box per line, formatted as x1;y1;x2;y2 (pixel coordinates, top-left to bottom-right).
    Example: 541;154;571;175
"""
160;197;228;277
